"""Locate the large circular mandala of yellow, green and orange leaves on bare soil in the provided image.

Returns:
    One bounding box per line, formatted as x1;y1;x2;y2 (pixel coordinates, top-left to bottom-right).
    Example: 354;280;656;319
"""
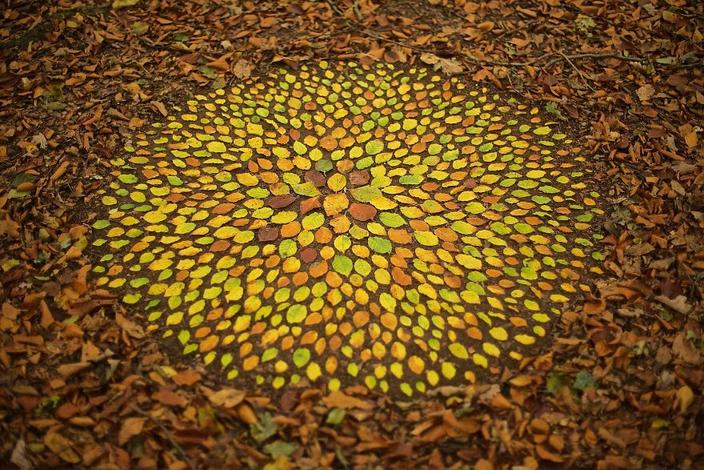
88;62;602;396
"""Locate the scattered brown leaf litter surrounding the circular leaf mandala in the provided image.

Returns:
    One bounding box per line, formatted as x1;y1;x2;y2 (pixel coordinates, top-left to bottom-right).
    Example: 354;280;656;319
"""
0;1;704;468
